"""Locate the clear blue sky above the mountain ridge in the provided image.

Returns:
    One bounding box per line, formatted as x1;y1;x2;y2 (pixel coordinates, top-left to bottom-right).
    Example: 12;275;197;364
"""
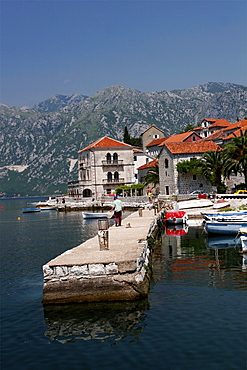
0;0;247;107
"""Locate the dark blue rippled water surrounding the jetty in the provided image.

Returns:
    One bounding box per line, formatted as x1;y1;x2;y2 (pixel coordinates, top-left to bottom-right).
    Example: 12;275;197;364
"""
0;201;247;370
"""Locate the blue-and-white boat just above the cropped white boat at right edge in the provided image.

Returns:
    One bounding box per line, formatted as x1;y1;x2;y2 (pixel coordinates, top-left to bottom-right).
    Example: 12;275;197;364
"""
204;219;247;235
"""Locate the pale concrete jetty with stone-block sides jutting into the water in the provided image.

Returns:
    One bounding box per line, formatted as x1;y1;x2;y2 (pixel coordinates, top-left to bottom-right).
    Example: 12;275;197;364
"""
43;210;162;304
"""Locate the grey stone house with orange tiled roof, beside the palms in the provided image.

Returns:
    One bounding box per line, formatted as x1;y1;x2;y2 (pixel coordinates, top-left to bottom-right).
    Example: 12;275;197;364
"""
159;141;221;195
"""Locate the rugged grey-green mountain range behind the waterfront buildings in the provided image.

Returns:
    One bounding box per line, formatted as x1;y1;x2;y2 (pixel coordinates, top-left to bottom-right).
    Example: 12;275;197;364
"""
0;82;247;196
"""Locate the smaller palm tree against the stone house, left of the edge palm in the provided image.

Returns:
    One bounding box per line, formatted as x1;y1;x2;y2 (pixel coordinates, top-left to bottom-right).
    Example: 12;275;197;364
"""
201;151;225;193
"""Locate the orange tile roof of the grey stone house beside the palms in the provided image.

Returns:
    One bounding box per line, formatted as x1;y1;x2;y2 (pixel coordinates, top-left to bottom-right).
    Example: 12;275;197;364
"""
164;141;222;154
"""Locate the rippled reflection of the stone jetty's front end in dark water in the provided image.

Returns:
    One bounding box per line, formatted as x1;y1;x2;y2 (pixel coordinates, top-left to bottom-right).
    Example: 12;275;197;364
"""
44;299;149;344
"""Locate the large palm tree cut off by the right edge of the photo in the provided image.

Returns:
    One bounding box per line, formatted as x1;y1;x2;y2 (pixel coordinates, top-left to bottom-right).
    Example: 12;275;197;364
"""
223;130;247;189
